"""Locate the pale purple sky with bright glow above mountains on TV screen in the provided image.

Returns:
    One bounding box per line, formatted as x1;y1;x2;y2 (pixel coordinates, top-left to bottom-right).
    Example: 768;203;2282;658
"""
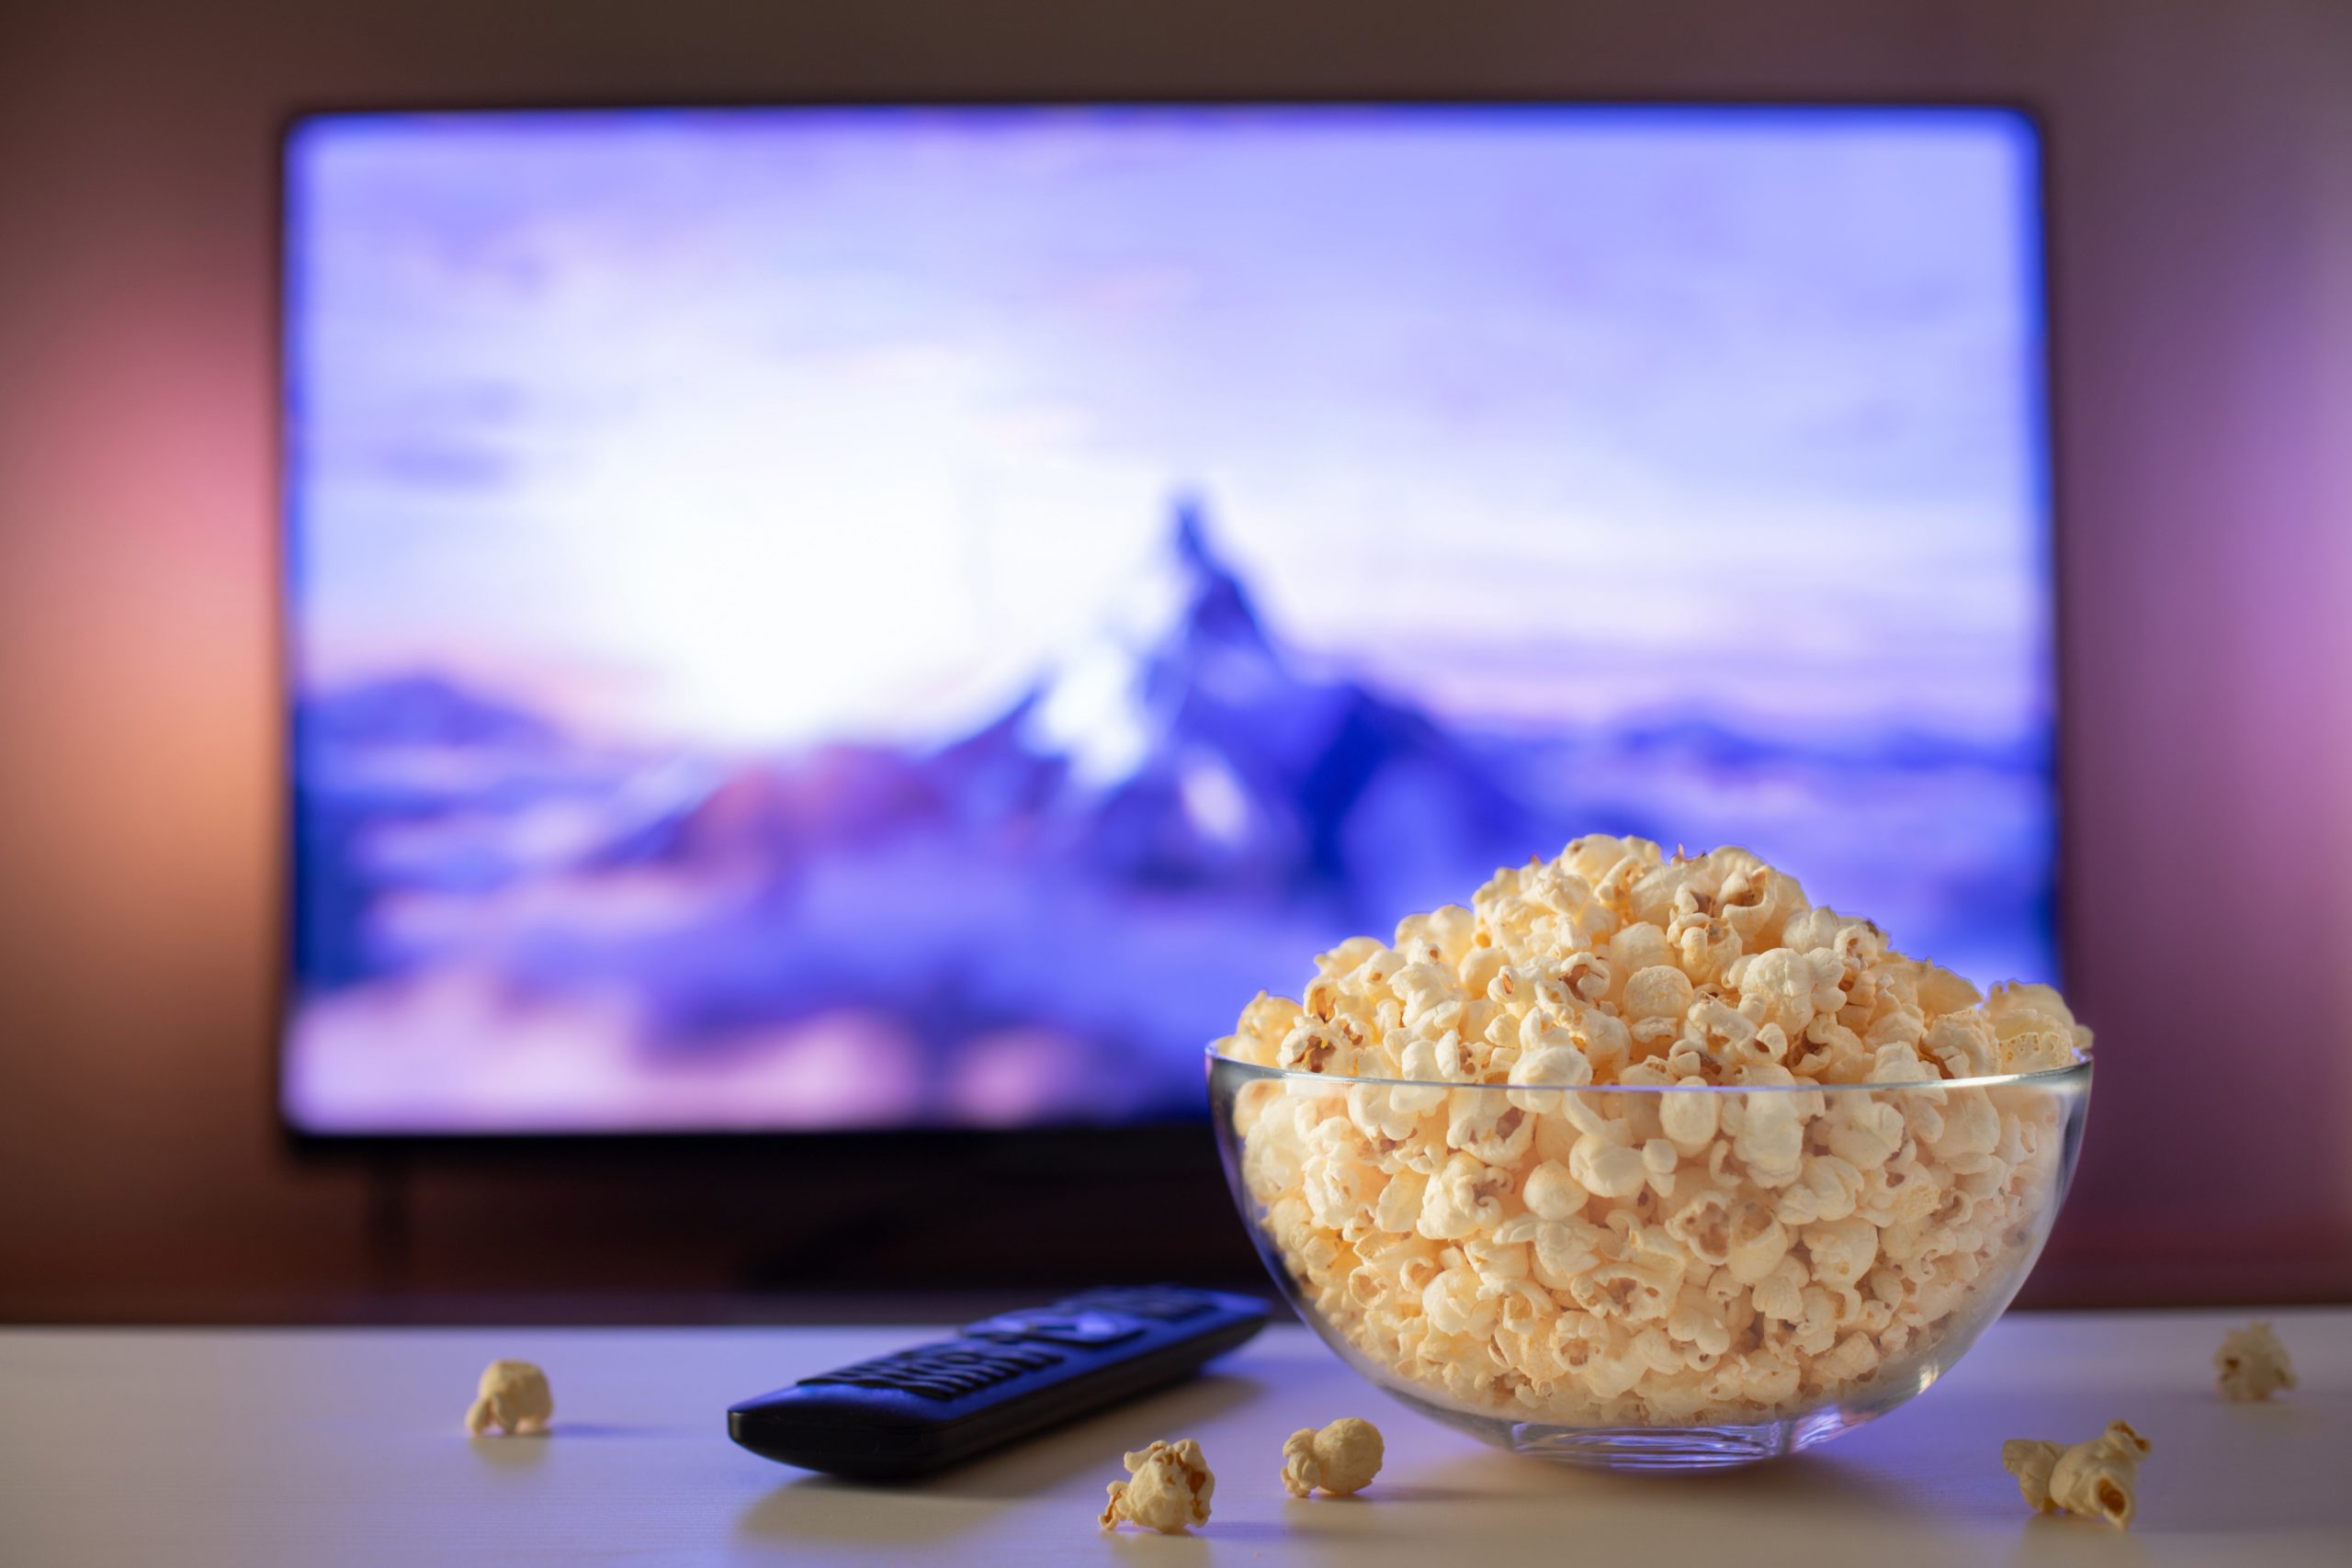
291;108;2049;748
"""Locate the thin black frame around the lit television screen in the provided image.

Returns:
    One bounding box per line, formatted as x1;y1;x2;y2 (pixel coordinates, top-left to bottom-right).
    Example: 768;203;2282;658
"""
266;92;2070;1178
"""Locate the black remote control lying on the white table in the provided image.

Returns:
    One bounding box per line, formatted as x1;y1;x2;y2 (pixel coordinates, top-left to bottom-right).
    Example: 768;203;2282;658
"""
727;1286;1265;1481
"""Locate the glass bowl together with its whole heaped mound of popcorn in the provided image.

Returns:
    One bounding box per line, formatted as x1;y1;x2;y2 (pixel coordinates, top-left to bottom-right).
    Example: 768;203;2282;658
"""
1209;835;2091;1470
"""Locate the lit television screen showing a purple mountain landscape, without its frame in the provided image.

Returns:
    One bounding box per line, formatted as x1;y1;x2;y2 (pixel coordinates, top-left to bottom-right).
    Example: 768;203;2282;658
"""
280;104;2053;1135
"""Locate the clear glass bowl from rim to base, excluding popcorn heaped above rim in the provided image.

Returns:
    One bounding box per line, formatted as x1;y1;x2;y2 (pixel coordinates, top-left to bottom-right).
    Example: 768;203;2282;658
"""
1209;1051;2091;1470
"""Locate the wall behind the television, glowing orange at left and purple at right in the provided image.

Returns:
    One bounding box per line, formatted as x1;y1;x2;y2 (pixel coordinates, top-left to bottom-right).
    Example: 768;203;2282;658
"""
0;0;2352;1316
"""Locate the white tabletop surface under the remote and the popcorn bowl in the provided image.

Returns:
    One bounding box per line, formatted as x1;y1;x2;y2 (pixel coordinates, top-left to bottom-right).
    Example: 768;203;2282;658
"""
0;1312;2352;1568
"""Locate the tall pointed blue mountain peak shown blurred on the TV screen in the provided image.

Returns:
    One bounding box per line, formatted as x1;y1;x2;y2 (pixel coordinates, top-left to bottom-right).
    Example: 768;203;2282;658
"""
933;503;1538;907
